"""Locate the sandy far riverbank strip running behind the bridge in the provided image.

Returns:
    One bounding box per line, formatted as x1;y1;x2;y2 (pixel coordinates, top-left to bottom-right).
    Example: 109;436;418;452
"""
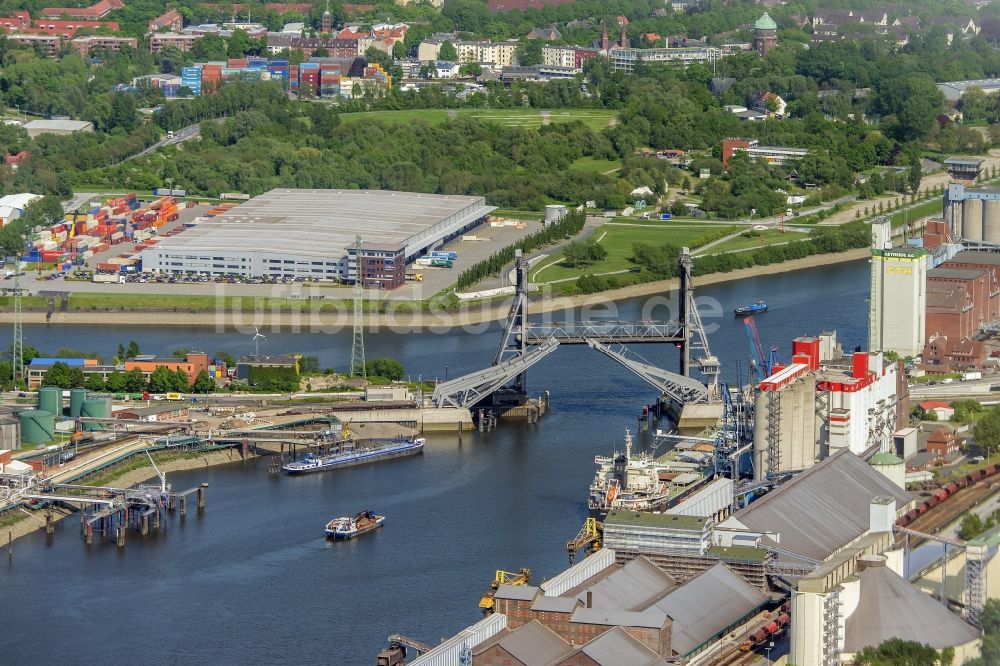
0;248;870;333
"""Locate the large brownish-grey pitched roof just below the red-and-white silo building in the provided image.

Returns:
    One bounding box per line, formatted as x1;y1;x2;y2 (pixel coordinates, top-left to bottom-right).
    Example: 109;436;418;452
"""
735;449;911;560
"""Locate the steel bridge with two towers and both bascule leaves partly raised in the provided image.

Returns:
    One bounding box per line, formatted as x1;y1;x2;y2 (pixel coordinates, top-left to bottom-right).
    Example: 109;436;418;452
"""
433;248;719;408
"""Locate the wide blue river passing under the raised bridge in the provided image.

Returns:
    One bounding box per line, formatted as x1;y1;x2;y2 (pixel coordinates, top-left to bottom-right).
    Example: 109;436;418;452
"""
0;262;868;665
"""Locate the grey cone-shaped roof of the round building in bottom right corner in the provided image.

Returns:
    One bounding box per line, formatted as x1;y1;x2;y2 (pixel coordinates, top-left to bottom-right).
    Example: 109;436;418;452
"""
844;562;979;652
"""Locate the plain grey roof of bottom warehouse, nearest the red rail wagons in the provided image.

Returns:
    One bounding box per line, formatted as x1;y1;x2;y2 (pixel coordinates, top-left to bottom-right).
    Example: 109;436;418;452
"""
654;563;767;655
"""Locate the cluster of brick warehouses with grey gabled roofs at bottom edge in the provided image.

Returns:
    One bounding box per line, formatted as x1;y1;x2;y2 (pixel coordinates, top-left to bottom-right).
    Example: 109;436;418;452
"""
412;548;769;666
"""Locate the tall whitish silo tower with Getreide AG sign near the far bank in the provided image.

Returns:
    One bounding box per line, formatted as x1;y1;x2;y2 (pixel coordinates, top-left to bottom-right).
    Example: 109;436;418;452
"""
868;220;927;357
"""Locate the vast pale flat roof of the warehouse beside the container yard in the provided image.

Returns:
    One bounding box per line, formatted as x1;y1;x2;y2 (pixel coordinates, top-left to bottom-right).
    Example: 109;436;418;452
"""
147;189;494;257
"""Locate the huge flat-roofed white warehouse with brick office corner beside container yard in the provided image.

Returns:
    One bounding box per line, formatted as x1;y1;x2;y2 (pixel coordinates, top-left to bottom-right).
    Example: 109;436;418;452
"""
143;189;495;289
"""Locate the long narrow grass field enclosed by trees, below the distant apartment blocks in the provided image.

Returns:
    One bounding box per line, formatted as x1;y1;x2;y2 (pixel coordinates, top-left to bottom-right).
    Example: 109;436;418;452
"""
340;109;617;130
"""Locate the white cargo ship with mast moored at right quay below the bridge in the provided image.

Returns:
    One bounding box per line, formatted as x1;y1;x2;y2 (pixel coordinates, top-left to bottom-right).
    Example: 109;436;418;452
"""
587;430;711;520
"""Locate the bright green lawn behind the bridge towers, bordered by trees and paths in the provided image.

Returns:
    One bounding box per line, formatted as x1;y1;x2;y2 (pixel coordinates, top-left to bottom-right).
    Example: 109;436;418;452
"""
530;222;733;282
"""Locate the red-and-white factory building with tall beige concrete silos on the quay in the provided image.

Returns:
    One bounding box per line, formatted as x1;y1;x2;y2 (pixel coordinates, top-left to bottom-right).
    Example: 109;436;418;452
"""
753;332;909;480
